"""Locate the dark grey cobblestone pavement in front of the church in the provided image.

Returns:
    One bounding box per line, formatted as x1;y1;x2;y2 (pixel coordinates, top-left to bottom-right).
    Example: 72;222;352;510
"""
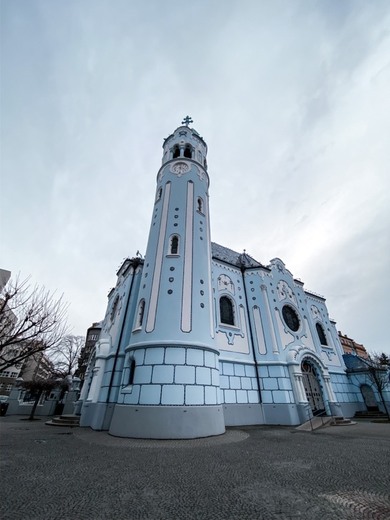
0;416;390;520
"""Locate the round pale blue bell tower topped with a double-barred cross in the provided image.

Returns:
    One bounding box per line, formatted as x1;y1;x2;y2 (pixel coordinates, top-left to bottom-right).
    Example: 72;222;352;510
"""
110;116;225;439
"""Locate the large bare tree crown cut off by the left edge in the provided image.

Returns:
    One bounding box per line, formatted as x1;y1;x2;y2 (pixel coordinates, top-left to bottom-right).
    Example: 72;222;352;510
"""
0;278;67;371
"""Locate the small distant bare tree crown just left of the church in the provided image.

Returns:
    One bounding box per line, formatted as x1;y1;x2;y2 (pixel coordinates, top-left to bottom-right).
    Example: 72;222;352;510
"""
48;335;85;377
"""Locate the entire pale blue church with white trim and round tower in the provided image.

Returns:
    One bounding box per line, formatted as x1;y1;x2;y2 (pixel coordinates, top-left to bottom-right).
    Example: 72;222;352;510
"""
80;116;386;439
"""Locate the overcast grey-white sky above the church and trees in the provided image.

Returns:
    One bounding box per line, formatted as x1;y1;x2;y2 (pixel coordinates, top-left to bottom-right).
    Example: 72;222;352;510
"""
0;0;390;353
